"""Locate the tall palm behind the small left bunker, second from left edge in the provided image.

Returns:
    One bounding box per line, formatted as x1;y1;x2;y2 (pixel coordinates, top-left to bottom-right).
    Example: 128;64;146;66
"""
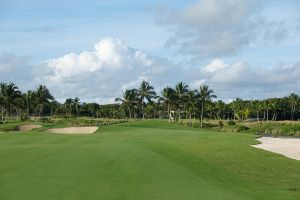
34;85;54;117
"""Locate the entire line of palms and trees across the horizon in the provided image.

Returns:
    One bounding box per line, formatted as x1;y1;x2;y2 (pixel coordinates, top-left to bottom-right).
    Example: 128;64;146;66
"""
0;81;300;127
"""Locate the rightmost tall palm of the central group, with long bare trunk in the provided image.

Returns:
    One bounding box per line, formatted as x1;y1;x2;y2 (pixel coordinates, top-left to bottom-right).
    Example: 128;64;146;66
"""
196;85;217;128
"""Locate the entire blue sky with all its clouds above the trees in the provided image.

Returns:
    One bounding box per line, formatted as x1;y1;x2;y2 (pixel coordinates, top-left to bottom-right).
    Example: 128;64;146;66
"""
0;0;300;102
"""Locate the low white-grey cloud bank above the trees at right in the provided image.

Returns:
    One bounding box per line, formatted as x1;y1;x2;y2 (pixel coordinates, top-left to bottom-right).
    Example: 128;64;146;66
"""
196;59;300;99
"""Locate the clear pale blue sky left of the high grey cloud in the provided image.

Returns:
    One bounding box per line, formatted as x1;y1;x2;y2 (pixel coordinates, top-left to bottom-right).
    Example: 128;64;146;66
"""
0;0;175;61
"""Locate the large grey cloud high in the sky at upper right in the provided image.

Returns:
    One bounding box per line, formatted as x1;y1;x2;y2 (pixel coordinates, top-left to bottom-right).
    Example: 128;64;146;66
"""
158;0;288;58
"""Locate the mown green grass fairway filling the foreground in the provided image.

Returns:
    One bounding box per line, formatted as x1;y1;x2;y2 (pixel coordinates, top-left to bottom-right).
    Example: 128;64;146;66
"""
0;121;300;200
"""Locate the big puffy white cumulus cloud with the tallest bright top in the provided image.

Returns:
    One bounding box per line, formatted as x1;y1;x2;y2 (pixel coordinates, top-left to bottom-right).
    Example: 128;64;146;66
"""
40;38;172;101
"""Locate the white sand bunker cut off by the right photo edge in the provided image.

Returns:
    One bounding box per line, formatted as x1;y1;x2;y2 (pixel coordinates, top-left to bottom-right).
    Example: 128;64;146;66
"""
252;137;300;160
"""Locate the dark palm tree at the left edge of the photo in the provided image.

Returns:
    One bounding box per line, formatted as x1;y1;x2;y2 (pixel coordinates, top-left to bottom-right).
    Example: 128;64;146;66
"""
0;83;22;118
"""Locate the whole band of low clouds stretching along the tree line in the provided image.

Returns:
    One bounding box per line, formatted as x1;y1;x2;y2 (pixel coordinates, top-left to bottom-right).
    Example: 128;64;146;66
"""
0;38;300;103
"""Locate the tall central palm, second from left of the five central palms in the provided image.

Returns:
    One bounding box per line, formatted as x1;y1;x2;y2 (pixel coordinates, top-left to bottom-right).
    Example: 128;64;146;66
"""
136;81;156;119
